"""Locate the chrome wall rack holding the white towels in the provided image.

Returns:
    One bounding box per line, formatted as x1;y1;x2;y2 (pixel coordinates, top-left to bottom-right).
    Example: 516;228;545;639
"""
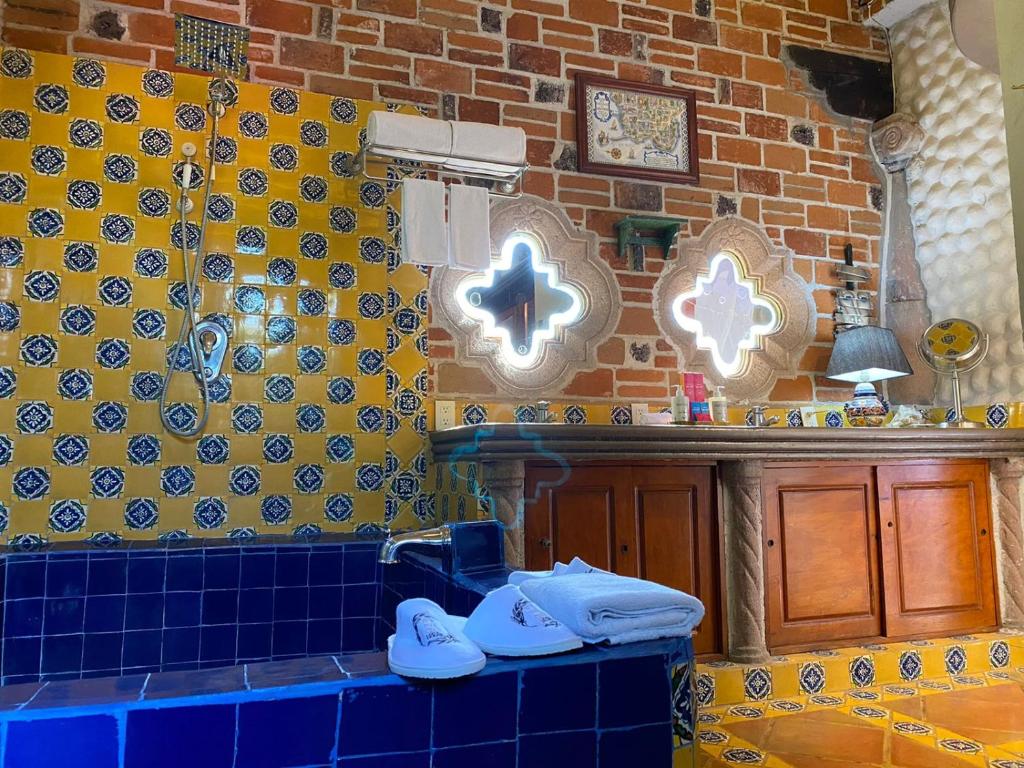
349;144;529;198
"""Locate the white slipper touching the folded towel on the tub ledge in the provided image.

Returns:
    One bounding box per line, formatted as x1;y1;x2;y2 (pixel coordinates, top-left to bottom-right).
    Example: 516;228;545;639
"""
453;584;583;656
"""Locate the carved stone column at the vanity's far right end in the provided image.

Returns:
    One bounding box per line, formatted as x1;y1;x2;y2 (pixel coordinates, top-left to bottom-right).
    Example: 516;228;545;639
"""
989;459;1024;629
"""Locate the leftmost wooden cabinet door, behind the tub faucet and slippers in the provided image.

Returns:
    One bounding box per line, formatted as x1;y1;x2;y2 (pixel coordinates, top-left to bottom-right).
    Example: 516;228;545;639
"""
525;467;630;570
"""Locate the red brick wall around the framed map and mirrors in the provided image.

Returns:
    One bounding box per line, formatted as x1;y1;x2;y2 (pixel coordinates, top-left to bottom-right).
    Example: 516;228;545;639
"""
3;0;888;401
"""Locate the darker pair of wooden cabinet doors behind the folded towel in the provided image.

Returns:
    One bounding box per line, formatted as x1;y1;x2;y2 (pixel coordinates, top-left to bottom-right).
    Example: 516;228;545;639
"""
524;463;723;655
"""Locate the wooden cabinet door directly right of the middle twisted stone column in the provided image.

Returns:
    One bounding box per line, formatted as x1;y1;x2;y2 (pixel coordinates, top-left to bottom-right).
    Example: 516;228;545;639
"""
763;465;882;648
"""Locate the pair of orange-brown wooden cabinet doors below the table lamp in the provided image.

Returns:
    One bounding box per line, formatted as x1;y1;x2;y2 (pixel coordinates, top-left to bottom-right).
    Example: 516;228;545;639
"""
763;461;997;651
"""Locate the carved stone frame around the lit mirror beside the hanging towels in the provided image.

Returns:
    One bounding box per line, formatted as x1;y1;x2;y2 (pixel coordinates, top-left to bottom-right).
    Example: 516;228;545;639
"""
430;195;622;398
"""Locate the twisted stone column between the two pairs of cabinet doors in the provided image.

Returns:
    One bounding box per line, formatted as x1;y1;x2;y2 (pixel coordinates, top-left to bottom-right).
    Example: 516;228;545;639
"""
721;461;769;664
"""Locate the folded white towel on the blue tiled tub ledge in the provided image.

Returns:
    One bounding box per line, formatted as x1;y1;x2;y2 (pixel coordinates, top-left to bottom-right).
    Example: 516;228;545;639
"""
519;572;705;645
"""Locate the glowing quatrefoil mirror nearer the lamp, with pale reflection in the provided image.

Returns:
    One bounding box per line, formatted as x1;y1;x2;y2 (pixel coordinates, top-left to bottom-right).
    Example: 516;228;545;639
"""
672;251;780;377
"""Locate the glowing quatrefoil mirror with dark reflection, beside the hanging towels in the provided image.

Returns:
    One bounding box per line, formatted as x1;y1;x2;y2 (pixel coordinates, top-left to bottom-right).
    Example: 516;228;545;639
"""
456;232;584;368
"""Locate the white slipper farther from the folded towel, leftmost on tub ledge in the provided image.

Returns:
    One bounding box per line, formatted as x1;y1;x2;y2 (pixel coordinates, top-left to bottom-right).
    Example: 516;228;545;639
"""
387;597;487;680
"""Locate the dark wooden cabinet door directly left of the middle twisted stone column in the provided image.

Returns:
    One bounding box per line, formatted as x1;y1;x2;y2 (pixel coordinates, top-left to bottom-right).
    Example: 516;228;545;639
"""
620;466;723;654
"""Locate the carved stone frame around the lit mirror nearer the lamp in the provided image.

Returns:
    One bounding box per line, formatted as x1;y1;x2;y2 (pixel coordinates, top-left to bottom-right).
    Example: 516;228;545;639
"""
654;218;817;400
